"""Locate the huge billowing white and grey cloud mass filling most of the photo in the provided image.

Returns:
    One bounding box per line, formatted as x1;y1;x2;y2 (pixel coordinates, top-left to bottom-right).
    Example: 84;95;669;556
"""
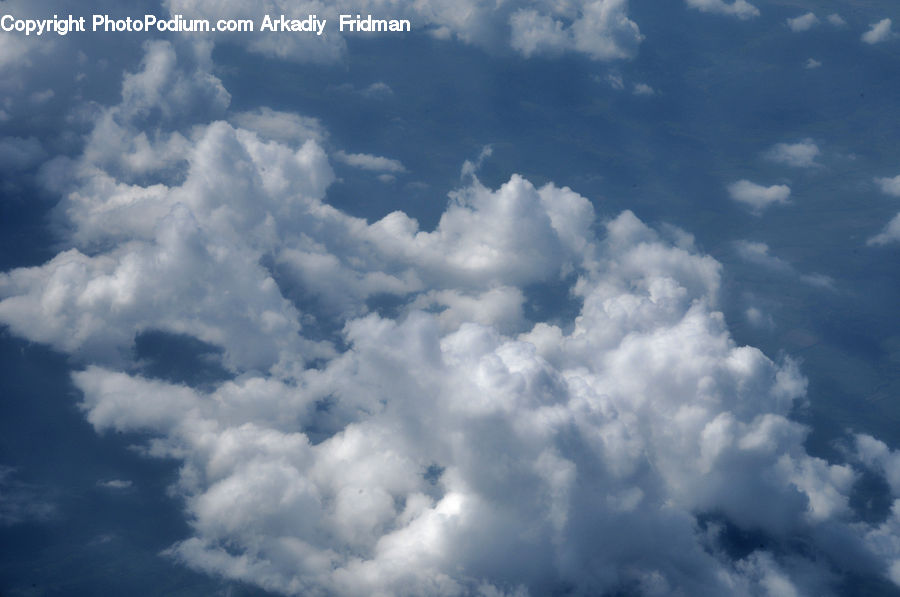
0;39;900;595
